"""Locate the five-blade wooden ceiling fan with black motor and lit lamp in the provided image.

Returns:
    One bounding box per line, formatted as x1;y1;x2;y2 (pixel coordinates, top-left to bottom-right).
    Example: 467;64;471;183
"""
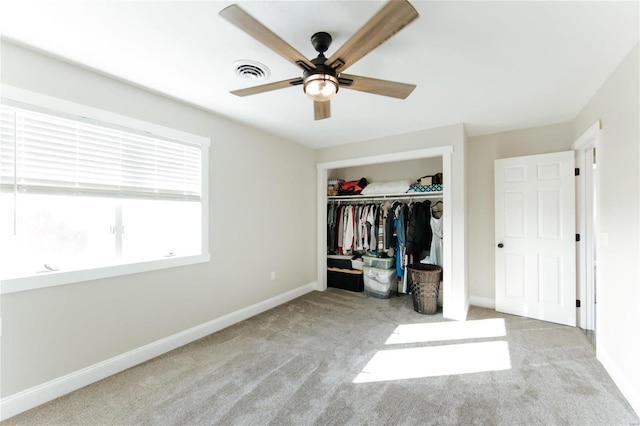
220;0;418;120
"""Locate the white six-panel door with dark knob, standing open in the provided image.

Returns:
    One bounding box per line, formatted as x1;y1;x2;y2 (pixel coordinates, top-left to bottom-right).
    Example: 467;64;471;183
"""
495;151;576;326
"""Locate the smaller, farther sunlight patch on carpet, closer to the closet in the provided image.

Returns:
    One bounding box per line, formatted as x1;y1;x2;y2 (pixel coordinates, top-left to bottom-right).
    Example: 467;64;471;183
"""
385;318;507;345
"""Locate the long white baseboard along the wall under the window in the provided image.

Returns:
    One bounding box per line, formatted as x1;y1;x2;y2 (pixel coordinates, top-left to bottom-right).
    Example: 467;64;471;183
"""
0;282;317;421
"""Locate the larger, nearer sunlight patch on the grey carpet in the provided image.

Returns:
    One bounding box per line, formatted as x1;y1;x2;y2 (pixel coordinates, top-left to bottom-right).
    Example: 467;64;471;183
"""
353;341;511;383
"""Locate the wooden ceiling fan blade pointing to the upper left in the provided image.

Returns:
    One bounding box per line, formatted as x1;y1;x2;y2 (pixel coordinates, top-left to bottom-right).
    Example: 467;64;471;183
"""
220;4;316;70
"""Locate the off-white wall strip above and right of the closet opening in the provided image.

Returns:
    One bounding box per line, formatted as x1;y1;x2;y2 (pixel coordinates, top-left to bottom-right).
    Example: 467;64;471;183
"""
316;124;468;319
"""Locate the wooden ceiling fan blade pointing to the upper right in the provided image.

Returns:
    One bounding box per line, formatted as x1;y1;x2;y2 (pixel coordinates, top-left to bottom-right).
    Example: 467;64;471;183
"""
325;0;418;72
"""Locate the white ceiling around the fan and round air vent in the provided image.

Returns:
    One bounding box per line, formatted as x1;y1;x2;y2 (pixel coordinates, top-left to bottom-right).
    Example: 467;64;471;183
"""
0;0;640;147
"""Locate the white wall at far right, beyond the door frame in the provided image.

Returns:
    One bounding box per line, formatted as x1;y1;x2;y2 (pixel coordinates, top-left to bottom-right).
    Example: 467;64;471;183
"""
573;44;640;413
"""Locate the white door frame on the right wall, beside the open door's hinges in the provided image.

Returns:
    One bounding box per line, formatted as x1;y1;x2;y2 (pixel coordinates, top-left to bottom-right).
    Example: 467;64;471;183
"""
571;120;602;336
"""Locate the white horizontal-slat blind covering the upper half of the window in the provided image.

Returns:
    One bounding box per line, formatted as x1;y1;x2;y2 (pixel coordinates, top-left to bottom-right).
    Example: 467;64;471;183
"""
0;105;201;200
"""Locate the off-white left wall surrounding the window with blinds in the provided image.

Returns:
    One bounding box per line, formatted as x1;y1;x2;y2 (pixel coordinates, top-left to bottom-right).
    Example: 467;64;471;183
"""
0;42;316;398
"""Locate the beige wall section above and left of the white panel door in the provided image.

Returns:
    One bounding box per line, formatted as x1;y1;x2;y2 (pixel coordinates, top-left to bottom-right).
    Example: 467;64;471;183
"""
467;123;573;308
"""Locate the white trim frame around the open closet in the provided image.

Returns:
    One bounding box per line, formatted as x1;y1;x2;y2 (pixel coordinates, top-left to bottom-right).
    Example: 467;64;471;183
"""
316;145;460;320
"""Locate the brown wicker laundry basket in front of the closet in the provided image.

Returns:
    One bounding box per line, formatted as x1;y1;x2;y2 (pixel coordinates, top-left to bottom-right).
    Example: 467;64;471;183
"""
407;263;442;315
